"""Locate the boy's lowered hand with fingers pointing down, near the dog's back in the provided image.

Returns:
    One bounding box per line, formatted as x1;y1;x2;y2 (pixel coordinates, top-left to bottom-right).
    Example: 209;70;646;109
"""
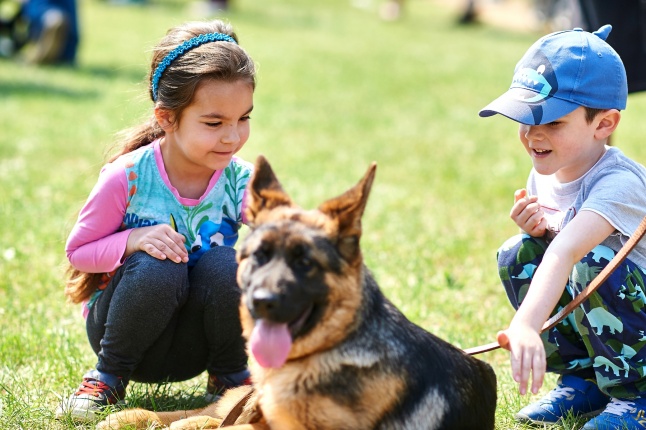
498;324;546;395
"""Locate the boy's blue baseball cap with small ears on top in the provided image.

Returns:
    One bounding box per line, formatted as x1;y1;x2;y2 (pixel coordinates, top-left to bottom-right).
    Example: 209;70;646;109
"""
479;25;628;125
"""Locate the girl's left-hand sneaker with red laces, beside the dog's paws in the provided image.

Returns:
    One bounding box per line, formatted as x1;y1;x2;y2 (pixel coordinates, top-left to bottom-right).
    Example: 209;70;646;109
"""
56;370;127;421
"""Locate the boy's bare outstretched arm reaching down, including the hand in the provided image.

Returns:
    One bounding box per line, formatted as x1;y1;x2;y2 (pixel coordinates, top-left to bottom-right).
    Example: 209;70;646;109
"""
498;210;615;394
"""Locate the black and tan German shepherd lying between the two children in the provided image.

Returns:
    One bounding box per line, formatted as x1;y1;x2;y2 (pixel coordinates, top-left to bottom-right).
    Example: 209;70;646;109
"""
98;156;496;430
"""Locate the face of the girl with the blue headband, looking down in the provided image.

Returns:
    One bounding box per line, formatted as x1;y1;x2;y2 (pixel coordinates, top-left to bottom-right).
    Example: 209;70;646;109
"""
157;80;253;175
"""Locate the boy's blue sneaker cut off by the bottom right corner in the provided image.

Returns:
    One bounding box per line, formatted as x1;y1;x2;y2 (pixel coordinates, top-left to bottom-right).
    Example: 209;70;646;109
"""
582;398;646;430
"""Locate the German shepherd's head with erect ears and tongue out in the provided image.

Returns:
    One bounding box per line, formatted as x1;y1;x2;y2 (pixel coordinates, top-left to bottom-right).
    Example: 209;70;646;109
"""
238;156;376;367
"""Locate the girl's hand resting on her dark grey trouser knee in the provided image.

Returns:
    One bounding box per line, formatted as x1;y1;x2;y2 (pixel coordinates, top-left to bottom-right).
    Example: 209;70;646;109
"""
124;224;188;263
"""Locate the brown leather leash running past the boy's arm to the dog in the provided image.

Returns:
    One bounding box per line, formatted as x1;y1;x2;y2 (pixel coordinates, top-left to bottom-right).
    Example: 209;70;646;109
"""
464;217;646;355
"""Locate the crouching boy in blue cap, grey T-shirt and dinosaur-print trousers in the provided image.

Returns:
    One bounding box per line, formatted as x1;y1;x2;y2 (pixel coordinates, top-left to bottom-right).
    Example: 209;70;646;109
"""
480;25;646;430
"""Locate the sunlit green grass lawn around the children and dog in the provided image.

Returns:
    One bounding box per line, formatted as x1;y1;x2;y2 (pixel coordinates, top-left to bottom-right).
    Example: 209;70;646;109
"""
0;0;646;429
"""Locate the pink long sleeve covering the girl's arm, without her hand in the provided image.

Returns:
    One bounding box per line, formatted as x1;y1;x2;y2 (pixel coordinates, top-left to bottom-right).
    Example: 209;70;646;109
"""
65;163;130;273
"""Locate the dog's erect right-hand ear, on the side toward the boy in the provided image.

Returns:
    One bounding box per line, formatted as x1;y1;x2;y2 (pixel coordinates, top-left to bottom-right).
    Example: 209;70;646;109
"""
319;162;377;260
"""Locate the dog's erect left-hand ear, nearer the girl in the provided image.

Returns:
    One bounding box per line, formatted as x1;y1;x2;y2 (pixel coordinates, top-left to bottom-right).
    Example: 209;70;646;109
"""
245;155;294;225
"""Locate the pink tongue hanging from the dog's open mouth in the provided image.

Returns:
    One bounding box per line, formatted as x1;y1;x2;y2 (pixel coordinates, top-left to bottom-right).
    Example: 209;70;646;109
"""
249;319;292;368
